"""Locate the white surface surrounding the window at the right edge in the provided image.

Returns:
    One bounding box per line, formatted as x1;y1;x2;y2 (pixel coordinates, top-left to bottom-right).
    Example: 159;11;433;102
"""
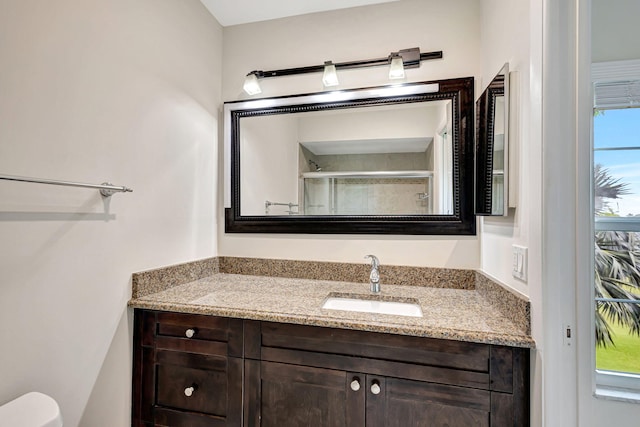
574;0;640;427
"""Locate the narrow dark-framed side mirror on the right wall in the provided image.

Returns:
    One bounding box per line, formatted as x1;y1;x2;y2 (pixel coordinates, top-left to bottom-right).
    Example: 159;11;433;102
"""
476;64;509;216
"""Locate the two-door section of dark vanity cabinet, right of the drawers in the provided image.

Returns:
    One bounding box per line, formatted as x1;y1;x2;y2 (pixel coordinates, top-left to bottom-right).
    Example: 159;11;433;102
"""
245;322;529;427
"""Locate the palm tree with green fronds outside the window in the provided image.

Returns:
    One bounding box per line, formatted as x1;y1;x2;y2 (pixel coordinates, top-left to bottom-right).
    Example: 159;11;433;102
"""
594;164;640;347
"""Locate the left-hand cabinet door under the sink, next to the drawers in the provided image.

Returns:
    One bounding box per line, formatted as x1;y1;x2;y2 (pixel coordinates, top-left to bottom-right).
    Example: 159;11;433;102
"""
247;361;365;427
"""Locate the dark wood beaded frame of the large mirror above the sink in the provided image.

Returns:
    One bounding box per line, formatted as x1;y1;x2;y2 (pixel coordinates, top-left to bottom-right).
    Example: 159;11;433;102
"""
225;77;476;235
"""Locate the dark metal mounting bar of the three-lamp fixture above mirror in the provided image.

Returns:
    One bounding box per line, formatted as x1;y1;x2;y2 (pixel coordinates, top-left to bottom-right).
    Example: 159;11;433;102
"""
249;47;442;79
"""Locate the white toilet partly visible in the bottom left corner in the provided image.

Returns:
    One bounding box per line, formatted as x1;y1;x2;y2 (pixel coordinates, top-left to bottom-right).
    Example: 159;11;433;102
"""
0;391;62;427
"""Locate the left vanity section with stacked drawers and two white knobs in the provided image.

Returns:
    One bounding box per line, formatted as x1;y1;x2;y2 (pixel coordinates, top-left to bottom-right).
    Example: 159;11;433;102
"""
131;310;243;427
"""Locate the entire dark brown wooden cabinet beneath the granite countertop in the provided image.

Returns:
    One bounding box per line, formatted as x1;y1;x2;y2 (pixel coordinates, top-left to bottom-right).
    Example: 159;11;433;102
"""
133;310;529;427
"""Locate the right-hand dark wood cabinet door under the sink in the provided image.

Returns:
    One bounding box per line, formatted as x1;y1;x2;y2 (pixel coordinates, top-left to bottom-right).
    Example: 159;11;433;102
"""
366;375;491;427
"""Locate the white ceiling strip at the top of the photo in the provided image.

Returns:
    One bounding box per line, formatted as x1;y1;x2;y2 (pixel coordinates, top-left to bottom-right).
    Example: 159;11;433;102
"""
200;0;399;27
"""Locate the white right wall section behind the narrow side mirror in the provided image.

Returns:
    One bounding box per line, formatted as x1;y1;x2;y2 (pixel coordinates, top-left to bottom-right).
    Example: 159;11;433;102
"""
477;0;540;295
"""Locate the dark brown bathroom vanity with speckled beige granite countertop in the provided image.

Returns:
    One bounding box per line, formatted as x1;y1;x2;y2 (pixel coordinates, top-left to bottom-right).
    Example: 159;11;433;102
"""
130;258;534;427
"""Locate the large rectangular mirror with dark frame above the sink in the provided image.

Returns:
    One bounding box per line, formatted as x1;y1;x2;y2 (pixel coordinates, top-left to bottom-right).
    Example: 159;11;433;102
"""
225;78;475;234
